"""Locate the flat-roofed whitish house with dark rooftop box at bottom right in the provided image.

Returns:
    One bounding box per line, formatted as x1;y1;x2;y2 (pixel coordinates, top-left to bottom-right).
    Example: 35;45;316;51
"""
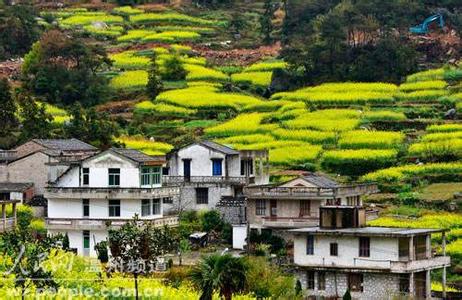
290;206;450;300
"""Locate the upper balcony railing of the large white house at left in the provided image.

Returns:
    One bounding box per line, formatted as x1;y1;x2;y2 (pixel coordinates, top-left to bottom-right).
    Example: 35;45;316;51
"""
45;187;180;199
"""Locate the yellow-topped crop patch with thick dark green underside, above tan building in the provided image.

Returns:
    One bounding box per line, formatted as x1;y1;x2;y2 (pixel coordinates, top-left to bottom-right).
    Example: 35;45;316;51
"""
321;149;397;176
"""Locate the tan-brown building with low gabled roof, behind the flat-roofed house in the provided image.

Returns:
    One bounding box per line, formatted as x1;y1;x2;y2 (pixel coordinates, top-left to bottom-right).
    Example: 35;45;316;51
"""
244;173;378;230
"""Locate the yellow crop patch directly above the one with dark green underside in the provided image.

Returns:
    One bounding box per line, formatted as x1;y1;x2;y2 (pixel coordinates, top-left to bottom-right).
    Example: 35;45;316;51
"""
338;130;405;149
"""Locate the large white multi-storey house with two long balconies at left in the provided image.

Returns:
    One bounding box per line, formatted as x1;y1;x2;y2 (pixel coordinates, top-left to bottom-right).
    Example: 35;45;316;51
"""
45;148;179;256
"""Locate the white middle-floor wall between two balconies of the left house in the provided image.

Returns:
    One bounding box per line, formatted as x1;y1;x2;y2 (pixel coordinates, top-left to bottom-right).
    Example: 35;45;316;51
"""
48;199;163;219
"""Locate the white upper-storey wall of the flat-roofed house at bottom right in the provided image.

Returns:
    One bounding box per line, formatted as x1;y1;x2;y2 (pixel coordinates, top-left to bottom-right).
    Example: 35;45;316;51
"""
294;234;399;267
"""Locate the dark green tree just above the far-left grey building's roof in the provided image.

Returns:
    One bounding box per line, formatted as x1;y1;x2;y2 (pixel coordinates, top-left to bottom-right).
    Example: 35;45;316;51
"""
17;93;53;142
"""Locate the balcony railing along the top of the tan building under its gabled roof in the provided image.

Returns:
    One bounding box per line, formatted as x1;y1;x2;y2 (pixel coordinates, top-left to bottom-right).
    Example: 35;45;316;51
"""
244;184;378;198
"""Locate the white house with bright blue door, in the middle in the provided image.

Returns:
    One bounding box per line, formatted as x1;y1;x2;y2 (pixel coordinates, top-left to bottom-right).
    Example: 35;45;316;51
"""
165;141;269;218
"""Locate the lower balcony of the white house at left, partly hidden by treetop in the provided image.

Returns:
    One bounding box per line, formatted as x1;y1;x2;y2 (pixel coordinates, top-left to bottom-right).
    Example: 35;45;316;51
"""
46;216;178;230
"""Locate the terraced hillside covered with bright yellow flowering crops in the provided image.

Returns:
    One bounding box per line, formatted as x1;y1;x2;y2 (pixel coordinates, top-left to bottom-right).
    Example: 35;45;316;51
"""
2;1;462;288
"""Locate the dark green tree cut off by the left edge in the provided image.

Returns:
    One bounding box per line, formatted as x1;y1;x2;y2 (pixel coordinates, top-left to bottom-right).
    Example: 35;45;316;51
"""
0;78;19;148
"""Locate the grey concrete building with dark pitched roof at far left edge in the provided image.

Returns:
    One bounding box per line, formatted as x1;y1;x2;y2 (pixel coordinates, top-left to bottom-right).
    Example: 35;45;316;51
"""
0;139;98;196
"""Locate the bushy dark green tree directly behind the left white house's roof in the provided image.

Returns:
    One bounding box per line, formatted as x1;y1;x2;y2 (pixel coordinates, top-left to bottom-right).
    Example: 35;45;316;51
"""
64;104;119;149
